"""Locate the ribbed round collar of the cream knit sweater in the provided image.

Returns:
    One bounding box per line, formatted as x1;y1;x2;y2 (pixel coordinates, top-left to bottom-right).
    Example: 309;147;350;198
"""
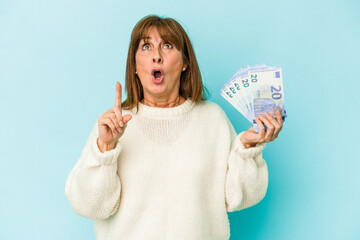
132;98;195;118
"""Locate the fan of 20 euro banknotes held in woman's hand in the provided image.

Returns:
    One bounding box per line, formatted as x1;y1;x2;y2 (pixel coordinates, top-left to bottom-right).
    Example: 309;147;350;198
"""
220;64;287;132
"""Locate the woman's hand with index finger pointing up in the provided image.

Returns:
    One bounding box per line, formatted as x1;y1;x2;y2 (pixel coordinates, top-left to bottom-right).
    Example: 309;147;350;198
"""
97;82;132;152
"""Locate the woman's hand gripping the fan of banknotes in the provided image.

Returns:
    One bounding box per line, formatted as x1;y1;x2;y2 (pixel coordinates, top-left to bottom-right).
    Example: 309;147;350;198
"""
240;111;283;148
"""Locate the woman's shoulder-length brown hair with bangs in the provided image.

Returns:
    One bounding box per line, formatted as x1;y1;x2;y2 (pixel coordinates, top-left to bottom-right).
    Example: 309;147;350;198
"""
121;15;206;109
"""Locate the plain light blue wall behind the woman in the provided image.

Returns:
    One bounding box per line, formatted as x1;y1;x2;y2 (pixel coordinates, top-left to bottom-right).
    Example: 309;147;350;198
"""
0;0;360;240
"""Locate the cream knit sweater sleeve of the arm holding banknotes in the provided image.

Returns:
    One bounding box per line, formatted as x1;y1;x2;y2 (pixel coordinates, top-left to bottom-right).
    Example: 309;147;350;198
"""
225;121;268;212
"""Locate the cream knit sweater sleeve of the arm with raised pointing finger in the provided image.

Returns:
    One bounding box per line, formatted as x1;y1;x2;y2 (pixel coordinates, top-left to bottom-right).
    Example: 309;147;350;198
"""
65;123;121;219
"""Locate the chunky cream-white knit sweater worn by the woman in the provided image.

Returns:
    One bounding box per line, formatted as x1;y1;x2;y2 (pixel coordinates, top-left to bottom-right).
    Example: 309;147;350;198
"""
65;100;268;240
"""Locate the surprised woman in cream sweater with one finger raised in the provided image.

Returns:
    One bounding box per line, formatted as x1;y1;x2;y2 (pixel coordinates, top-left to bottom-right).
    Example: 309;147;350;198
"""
65;16;282;240
